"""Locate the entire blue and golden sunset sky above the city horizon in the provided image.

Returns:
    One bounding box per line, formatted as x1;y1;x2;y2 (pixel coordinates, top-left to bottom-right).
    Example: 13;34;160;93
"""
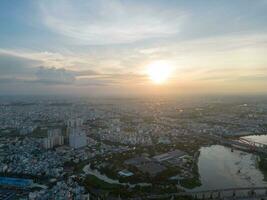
0;0;267;96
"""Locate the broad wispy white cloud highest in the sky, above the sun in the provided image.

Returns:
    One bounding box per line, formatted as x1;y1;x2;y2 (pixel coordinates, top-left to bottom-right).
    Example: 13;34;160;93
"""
39;0;185;44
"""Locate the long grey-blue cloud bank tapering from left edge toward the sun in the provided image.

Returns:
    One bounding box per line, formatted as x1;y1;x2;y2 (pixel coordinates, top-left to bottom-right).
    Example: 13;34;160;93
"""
0;50;147;92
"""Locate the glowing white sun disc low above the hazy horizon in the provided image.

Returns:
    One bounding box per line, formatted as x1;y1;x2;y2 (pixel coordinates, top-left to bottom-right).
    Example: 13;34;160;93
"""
147;61;172;84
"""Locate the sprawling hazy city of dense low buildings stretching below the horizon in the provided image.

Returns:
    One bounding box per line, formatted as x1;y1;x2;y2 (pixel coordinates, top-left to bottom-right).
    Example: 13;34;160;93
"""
0;97;267;199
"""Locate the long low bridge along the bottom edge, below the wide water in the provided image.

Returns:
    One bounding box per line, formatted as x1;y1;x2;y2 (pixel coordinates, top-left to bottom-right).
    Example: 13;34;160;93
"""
147;187;267;200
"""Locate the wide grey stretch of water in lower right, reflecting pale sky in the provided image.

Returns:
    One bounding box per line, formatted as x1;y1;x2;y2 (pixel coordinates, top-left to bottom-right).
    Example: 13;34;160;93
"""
194;145;267;190
